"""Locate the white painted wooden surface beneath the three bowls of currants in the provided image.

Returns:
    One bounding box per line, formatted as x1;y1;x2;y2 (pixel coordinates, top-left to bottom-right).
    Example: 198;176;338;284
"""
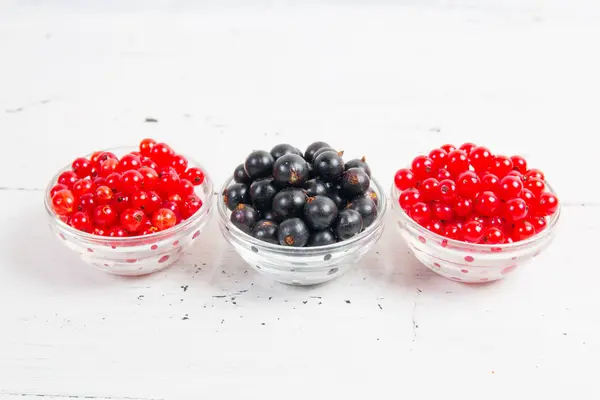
0;0;600;399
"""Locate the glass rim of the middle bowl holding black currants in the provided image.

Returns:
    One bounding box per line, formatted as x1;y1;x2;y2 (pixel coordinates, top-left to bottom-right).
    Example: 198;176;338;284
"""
217;176;388;255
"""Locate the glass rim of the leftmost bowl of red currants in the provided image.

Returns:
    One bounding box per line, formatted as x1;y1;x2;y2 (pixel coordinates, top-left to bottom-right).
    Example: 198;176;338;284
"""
44;145;213;244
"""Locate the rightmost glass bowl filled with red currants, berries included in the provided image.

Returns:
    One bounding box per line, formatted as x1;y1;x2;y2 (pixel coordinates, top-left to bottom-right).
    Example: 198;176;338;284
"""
392;143;560;283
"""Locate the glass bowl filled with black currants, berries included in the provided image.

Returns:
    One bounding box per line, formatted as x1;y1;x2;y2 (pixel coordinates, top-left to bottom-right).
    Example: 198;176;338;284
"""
218;142;387;285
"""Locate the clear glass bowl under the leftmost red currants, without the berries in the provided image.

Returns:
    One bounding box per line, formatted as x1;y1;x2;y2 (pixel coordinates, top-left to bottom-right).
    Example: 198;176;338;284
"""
44;146;213;276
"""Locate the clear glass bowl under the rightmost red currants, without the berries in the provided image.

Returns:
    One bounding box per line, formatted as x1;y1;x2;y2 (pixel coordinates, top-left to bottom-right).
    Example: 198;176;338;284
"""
392;183;560;283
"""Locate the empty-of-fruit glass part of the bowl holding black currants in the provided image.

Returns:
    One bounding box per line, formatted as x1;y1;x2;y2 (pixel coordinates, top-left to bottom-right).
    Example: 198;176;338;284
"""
217;178;387;285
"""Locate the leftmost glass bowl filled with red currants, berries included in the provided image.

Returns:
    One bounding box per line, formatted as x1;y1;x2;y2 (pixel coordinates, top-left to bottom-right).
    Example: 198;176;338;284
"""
45;139;212;276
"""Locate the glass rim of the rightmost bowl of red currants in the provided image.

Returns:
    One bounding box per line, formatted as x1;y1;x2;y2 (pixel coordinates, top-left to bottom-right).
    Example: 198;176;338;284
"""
391;180;562;251
